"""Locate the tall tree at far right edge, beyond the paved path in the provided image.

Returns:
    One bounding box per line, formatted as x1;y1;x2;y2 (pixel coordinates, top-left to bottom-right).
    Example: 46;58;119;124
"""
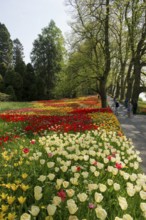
125;0;146;103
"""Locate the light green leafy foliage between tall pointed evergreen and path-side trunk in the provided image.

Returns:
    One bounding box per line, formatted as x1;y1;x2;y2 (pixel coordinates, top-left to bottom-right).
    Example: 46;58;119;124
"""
55;42;96;97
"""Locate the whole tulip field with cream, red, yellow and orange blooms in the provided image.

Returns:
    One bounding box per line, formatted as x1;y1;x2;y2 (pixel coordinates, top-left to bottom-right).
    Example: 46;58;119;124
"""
0;96;146;220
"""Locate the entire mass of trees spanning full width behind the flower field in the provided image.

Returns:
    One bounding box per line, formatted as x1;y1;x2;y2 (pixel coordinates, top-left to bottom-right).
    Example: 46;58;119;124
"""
0;0;146;113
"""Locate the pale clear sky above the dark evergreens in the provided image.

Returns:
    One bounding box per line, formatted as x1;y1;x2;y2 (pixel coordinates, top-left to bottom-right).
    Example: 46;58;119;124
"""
0;0;70;63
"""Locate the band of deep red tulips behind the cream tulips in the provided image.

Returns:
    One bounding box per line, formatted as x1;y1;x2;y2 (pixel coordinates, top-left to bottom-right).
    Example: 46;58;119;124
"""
0;108;112;132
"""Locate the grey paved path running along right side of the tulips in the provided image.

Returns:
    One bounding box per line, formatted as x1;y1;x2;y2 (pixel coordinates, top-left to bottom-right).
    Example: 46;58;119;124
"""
108;97;146;173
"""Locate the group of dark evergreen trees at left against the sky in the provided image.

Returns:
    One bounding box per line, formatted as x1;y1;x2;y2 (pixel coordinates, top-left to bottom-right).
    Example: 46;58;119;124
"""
0;20;65;101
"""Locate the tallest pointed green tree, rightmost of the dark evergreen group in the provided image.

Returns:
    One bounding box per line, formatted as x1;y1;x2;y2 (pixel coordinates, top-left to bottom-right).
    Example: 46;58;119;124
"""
31;20;64;98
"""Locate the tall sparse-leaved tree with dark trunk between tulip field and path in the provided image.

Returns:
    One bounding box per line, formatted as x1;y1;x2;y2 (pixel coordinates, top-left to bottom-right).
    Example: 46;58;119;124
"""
67;0;111;107
